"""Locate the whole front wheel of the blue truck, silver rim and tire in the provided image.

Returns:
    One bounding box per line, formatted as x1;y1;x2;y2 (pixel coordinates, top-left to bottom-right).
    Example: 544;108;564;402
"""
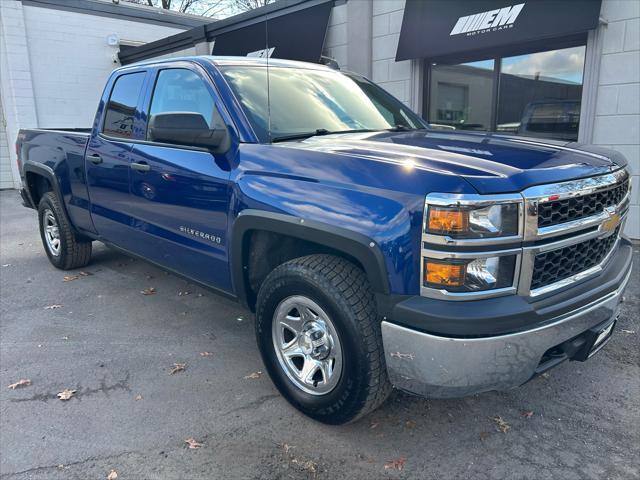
256;255;391;424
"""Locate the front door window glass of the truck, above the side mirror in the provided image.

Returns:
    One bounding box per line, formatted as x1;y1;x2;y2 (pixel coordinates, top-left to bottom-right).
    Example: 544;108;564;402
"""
147;68;222;140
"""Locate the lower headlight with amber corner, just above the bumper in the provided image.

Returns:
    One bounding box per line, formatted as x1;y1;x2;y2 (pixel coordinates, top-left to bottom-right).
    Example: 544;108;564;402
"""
422;255;517;293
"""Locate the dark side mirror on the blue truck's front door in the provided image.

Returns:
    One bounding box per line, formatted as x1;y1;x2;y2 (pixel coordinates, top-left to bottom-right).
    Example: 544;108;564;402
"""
149;112;230;153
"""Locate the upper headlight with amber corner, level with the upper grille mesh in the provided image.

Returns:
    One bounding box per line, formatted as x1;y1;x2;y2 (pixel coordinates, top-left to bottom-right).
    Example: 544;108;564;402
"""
425;203;520;239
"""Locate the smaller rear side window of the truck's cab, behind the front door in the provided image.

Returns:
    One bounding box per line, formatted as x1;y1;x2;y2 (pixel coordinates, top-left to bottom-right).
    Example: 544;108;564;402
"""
102;72;146;138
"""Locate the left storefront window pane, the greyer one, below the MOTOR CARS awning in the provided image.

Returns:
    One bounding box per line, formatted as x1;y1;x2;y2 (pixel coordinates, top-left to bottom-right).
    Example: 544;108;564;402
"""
429;60;494;130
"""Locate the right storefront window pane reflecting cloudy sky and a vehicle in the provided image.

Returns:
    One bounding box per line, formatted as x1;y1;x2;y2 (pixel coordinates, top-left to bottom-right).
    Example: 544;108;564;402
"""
496;46;585;140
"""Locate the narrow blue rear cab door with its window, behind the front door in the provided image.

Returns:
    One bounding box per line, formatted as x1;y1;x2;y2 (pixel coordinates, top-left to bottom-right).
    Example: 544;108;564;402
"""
85;70;147;248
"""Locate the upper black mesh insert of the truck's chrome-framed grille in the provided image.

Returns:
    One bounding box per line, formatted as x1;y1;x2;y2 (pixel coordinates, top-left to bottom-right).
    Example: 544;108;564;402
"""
538;179;629;228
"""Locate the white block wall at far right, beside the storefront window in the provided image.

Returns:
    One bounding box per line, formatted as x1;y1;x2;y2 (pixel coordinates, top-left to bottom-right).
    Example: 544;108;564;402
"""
593;0;640;238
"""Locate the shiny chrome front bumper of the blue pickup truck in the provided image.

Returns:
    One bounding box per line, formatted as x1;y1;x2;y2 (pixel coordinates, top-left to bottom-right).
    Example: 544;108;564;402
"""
382;247;631;398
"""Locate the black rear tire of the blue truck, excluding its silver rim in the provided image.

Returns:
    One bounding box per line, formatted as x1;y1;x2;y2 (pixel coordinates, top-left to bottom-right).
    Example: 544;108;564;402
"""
38;192;91;270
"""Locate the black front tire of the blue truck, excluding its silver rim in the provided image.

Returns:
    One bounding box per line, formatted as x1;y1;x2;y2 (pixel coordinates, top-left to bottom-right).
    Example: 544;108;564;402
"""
256;255;391;425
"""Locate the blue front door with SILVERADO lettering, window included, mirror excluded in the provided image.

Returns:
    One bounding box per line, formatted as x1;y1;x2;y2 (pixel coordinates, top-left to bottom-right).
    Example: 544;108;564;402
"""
129;64;232;292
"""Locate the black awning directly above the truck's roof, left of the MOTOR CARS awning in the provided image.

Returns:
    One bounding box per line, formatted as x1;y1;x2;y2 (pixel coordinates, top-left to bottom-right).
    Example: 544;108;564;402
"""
212;2;333;63
